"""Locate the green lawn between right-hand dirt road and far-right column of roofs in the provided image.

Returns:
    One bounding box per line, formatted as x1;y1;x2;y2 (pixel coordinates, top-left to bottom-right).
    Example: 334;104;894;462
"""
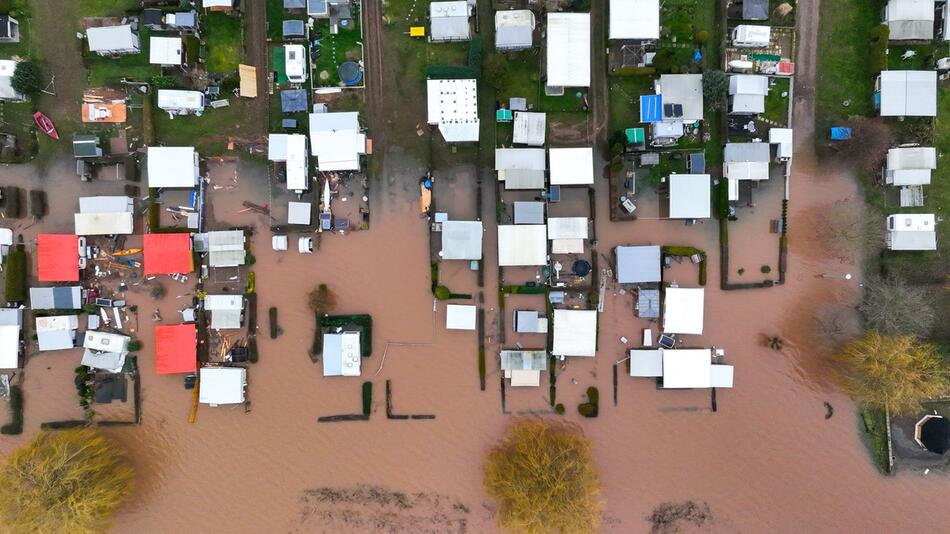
815;0;881;140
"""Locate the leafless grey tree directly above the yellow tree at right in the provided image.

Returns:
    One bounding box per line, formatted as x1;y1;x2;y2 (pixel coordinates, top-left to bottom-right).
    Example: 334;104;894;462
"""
858;276;936;338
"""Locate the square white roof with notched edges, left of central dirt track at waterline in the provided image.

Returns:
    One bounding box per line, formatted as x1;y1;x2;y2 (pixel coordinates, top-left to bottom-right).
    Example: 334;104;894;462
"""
310;111;366;172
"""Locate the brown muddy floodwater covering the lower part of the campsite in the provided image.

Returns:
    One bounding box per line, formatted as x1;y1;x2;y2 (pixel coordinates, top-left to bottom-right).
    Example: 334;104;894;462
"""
0;140;950;533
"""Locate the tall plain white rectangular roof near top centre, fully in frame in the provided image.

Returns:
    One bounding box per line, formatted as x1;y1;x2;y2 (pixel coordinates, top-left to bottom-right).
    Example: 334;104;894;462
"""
546;13;590;87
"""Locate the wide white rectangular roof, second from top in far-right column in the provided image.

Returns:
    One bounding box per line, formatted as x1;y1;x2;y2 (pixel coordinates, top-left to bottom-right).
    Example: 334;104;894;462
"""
880;70;937;117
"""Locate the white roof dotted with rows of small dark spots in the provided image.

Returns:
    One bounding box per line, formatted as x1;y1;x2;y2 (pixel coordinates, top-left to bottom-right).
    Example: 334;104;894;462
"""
426;80;479;143
